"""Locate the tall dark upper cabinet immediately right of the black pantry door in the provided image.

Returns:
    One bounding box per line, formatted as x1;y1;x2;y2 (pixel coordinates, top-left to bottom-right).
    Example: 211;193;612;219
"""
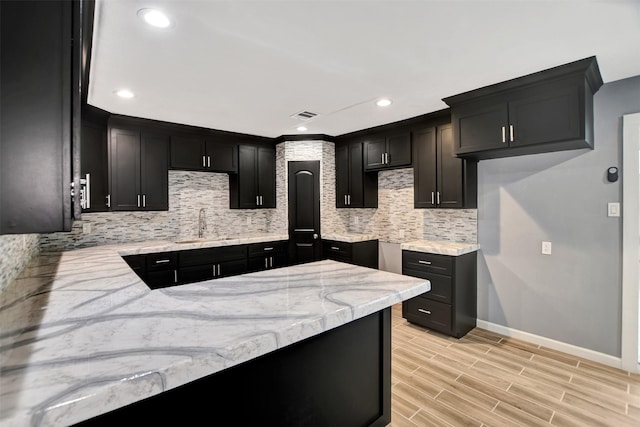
335;141;378;208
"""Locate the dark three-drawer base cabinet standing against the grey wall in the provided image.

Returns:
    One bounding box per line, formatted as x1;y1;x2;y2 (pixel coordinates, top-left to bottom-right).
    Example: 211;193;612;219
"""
402;251;477;338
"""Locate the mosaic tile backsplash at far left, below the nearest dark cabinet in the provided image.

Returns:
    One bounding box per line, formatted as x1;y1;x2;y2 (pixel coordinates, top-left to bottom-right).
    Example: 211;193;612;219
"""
0;234;38;292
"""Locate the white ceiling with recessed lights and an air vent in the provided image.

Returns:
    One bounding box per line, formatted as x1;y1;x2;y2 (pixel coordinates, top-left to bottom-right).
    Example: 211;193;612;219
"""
88;0;640;137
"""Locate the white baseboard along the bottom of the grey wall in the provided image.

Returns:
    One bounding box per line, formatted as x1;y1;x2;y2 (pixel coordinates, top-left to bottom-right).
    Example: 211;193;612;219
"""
476;319;622;369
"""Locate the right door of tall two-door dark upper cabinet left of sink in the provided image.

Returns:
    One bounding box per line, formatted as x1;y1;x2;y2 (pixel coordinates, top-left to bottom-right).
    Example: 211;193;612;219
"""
140;133;169;211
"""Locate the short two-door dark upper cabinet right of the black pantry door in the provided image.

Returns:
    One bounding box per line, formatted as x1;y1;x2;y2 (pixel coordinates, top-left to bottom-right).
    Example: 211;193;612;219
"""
364;131;411;171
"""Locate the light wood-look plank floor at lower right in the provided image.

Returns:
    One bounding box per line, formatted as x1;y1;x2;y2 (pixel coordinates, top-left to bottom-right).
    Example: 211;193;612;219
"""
391;305;640;427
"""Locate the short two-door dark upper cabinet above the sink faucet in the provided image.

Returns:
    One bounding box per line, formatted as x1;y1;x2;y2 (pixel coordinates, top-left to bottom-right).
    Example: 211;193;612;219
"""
170;135;238;173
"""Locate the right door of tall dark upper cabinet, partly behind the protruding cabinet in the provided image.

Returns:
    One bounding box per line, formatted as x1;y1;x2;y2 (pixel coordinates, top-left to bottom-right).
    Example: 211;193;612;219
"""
436;126;464;208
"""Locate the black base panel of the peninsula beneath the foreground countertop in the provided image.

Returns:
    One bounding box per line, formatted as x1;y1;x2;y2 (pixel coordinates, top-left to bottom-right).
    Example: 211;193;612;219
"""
80;308;391;427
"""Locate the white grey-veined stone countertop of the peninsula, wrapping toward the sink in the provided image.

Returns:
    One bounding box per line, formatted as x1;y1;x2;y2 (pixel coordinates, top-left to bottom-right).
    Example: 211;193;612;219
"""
0;239;430;426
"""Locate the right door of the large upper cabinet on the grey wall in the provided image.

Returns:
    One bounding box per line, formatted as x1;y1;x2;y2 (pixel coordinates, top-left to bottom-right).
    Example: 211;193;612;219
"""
509;82;584;147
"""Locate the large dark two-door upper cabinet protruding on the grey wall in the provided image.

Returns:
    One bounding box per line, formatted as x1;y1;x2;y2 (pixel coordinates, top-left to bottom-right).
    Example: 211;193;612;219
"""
444;57;602;159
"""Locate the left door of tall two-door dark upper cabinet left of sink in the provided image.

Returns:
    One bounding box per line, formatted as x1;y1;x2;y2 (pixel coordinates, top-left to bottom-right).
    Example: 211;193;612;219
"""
109;128;142;211
